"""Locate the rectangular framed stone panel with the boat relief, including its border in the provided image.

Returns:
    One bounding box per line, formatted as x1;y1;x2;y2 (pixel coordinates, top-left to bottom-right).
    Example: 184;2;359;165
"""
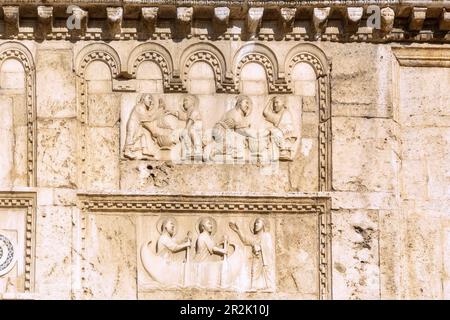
81;195;331;299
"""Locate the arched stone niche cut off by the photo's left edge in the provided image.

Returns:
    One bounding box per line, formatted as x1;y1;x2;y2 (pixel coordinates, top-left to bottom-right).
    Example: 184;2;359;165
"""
0;42;36;188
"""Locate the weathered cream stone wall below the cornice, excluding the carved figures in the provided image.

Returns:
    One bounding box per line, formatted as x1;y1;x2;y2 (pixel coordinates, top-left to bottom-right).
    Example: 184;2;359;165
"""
0;1;450;299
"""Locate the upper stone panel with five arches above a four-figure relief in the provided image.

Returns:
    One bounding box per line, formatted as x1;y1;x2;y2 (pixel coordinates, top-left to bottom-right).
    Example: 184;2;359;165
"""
75;41;329;192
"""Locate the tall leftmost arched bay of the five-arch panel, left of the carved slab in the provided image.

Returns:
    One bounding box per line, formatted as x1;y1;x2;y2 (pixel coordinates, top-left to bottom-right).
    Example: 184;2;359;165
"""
75;44;121;190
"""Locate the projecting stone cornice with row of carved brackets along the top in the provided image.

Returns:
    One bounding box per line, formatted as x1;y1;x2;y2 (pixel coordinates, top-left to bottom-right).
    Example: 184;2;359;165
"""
0;0;450;43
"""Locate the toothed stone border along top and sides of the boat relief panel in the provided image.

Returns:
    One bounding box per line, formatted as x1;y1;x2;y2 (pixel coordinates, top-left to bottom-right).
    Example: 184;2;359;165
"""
78;193;332;300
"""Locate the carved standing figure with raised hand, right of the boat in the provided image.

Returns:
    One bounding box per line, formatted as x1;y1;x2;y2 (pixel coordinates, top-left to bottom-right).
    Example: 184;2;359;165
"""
229;218;275;290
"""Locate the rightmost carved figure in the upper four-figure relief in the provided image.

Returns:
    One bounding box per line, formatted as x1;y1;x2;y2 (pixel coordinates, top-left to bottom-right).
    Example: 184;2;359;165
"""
263;96;298;160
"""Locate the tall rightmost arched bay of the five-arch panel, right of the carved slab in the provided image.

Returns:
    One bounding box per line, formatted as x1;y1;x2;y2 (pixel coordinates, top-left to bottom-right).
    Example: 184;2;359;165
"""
285;44;331;191
